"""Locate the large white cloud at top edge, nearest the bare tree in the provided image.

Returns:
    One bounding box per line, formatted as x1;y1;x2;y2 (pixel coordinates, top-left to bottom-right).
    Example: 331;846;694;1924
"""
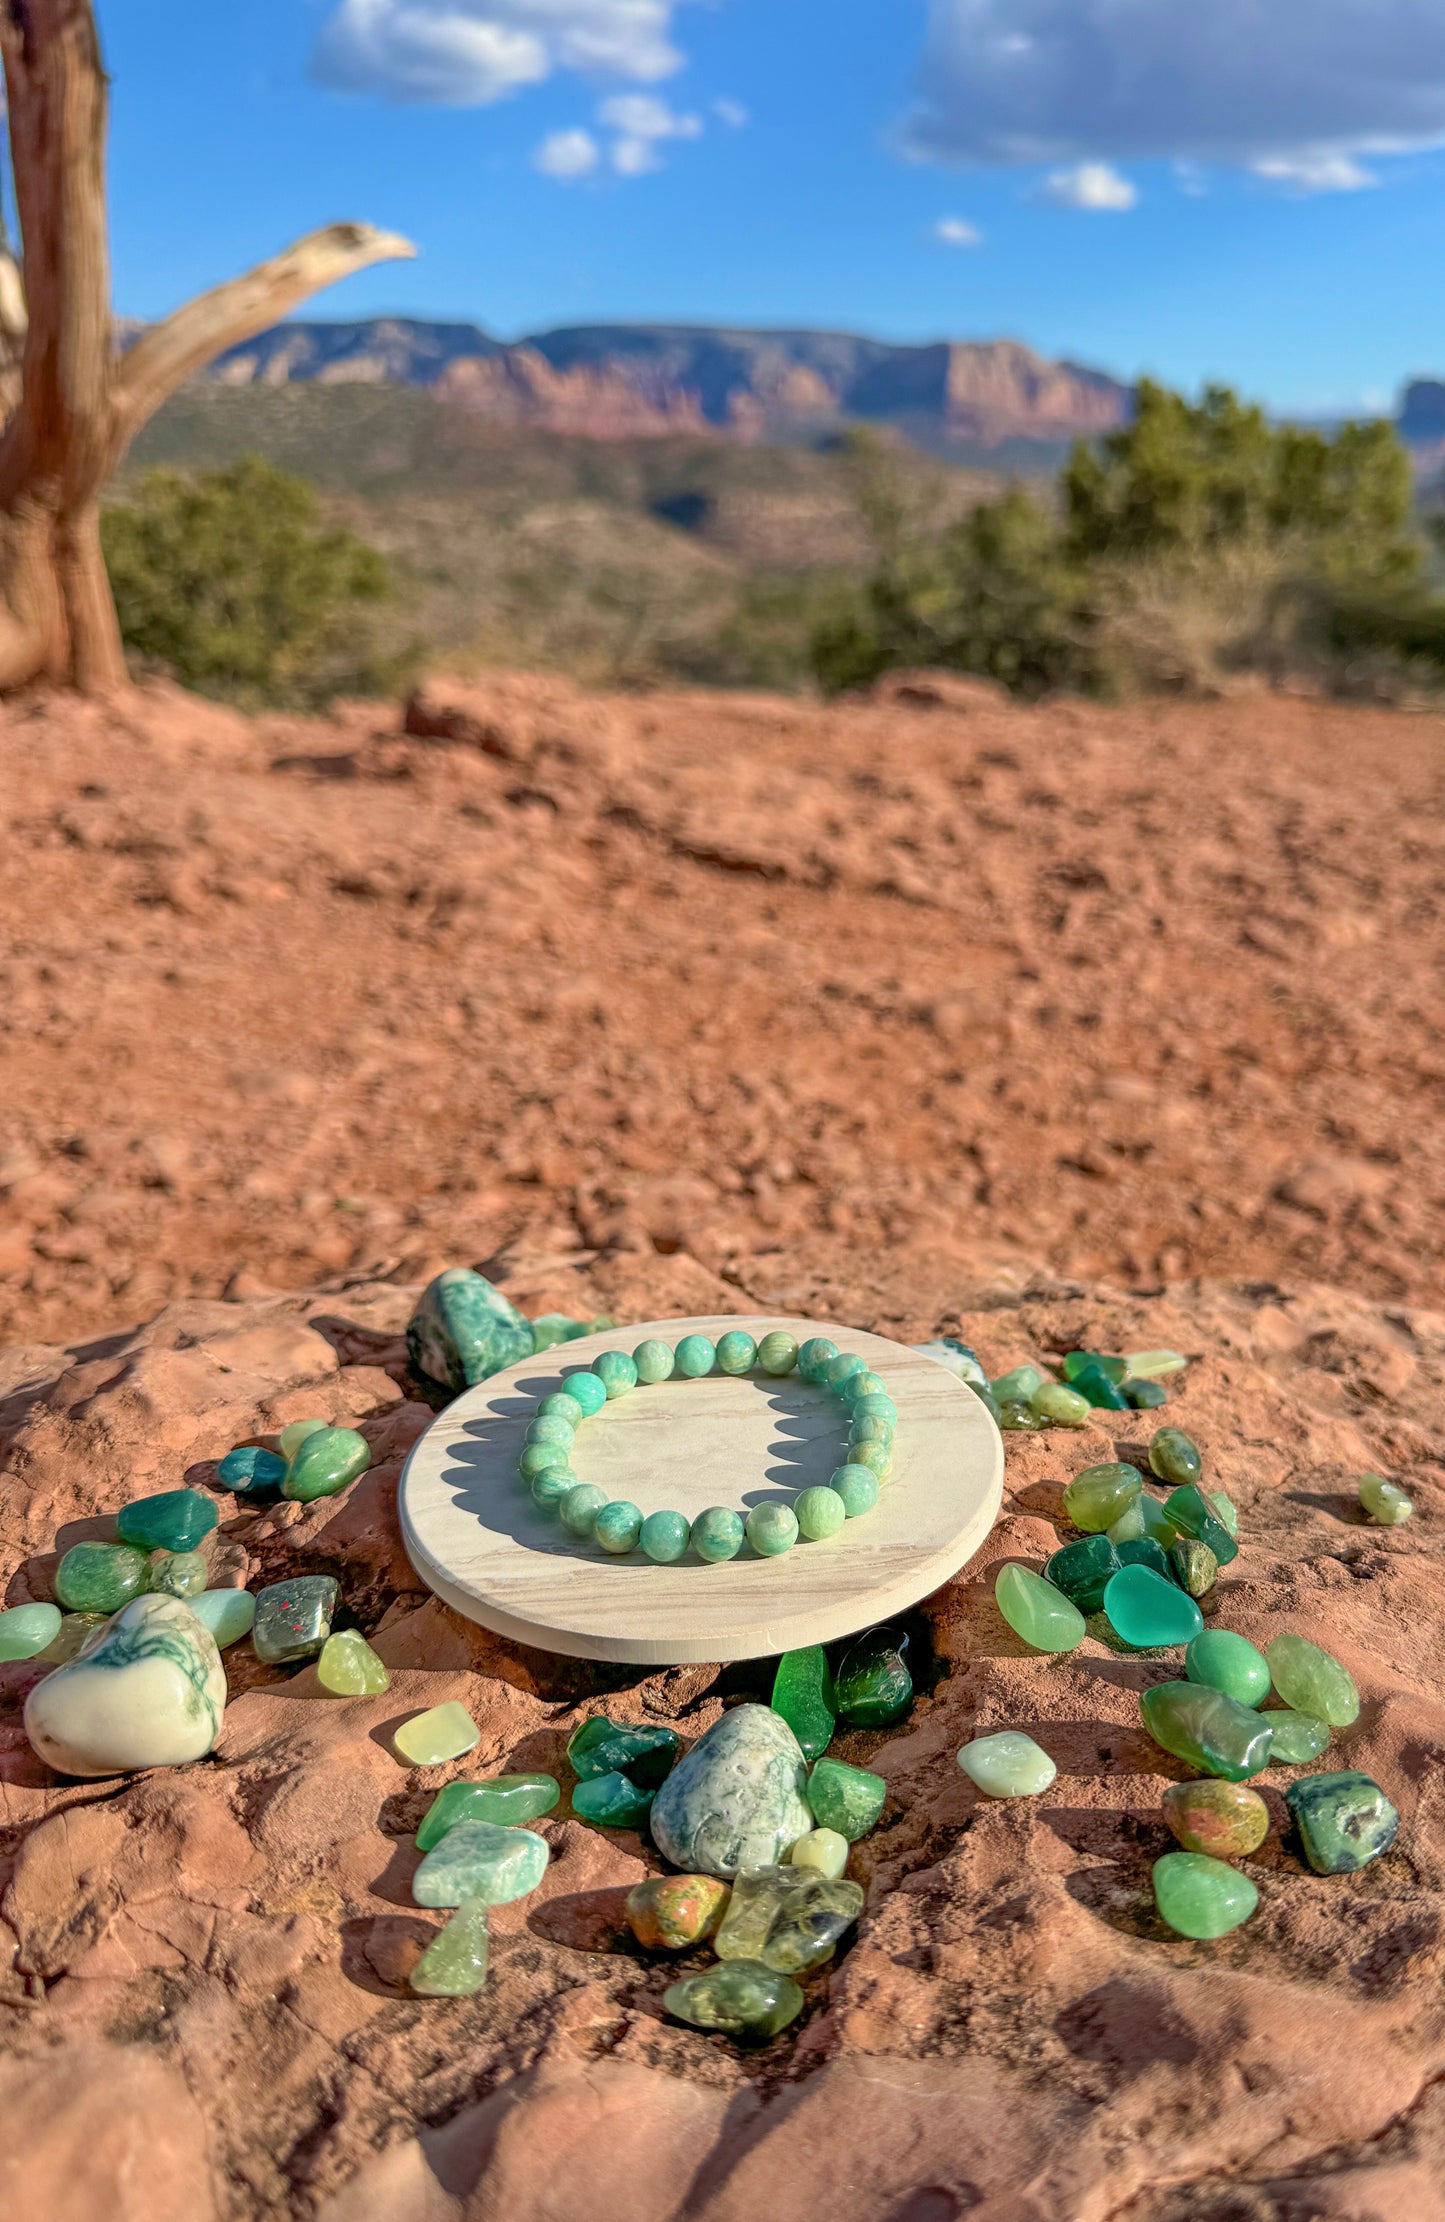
311;0;682;109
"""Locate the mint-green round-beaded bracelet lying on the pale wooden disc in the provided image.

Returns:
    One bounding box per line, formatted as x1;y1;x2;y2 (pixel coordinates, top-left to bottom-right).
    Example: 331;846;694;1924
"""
520;1329;898;1567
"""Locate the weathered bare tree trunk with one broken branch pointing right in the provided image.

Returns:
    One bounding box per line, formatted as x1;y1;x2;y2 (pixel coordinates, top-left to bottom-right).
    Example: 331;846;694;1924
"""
0;0;416;693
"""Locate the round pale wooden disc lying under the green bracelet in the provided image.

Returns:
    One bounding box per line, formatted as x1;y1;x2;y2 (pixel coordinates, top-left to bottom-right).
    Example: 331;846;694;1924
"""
400;1318;1003;1667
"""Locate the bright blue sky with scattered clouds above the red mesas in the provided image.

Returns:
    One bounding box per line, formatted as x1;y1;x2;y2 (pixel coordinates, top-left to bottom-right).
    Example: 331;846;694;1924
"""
98;0;1445;411
